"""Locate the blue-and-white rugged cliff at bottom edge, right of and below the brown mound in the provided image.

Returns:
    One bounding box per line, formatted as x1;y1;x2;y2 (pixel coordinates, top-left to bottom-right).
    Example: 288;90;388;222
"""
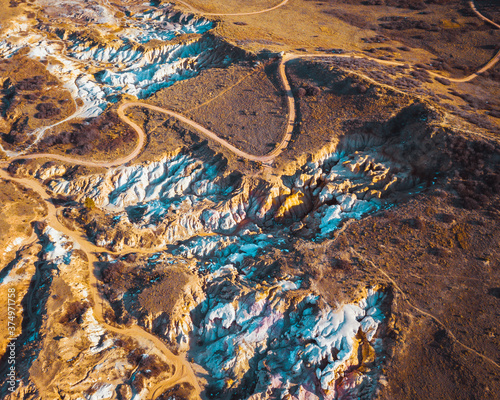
192;281;384;399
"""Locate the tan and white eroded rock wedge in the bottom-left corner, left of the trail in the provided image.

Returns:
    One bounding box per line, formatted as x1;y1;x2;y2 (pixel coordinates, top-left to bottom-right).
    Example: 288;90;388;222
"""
0;224;174;400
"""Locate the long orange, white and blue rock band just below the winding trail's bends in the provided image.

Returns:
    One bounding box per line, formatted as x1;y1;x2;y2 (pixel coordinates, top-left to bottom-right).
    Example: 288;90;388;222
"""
45;105;447;248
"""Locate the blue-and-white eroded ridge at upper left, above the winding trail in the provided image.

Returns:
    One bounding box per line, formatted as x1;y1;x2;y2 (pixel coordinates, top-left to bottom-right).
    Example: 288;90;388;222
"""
68;35;248;99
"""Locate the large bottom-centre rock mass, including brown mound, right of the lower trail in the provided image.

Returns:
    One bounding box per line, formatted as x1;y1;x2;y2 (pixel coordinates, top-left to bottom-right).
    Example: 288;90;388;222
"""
96;234;388;399
